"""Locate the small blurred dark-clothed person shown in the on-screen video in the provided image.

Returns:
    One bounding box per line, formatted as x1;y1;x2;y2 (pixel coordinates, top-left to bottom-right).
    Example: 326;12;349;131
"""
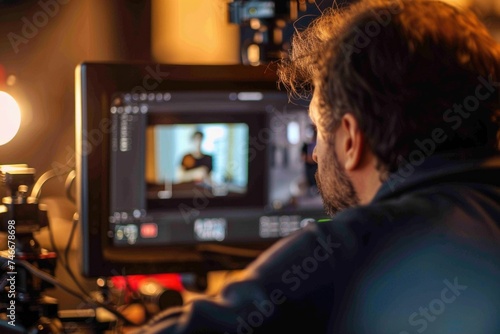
179;131;213;184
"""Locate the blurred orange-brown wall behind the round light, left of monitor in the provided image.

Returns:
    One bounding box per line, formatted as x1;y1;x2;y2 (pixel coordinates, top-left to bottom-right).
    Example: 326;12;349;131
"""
0;0;151;195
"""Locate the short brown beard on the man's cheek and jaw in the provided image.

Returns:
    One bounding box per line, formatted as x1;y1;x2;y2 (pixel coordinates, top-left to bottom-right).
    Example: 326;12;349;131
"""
315;152;359;216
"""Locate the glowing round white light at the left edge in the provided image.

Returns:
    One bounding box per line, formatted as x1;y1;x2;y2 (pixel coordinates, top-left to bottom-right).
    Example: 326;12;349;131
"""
0;91;21;145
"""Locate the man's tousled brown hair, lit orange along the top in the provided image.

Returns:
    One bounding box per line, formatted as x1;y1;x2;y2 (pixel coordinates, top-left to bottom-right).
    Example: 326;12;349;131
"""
278;0;500;172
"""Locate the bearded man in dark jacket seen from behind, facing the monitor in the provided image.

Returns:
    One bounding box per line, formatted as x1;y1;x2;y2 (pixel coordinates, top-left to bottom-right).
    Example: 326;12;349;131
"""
135;0;500;334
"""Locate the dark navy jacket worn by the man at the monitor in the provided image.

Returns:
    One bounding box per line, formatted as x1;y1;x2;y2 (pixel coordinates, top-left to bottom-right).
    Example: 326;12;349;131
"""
140;158;500;334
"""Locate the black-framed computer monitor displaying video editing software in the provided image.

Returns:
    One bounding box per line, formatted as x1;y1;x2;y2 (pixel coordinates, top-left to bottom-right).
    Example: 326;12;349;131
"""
76;63;324;277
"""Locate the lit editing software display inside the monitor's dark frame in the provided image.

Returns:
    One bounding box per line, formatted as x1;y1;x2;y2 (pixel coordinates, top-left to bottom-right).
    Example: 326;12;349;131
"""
108;91;322;247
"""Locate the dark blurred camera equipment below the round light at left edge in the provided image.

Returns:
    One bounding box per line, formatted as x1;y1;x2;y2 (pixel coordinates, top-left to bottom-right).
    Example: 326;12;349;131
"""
0;165;62;333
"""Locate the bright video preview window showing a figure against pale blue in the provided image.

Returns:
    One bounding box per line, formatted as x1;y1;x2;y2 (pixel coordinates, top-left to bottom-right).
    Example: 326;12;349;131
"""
145;123;249;199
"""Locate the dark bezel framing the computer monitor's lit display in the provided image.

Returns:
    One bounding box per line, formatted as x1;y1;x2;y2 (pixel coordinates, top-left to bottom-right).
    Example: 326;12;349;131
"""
75;63;290;277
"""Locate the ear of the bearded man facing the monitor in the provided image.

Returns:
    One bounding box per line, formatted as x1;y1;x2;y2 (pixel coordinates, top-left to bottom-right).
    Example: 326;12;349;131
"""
339;113;365;171
